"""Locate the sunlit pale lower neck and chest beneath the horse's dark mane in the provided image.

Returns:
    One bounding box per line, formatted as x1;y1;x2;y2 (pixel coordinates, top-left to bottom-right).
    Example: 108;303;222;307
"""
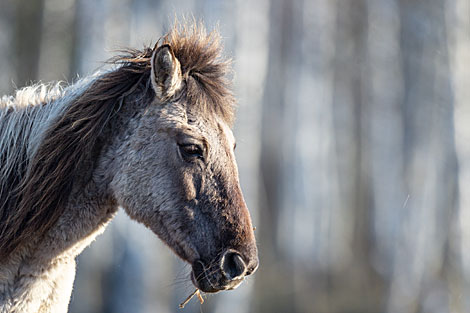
0;178;117;313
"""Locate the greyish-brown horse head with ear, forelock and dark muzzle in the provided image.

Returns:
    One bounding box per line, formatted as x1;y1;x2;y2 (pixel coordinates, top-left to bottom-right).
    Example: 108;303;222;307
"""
111;26;258;292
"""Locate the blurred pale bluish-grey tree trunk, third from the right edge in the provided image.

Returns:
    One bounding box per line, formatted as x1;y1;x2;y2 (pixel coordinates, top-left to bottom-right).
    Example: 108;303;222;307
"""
363;0;408;279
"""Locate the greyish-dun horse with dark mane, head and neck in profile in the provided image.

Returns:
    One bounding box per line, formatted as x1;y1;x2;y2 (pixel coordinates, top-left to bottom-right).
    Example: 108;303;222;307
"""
0;23;258;312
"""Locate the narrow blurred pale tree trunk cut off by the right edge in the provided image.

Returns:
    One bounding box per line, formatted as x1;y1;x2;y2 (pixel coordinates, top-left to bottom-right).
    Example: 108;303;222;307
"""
454;0;470;313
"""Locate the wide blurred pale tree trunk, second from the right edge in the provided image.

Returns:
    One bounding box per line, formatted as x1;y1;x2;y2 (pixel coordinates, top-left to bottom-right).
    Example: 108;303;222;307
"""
382;0;457;313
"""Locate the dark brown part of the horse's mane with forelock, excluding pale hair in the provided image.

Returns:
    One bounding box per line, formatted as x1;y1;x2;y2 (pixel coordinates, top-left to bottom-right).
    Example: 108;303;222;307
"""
0;26;234;260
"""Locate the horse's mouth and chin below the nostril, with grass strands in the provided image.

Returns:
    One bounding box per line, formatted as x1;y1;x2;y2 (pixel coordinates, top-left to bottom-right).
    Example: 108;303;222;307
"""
191;261;244;293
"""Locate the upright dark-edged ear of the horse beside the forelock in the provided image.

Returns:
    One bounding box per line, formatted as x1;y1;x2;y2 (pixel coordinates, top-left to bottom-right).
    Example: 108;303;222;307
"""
151;44;183;101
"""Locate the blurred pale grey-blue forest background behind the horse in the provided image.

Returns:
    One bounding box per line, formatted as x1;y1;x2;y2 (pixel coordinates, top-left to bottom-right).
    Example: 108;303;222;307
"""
0;0;470;313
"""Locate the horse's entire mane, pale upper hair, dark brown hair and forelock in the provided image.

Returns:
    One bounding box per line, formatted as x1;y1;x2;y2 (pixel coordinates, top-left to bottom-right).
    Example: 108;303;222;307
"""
0;24;234;260
